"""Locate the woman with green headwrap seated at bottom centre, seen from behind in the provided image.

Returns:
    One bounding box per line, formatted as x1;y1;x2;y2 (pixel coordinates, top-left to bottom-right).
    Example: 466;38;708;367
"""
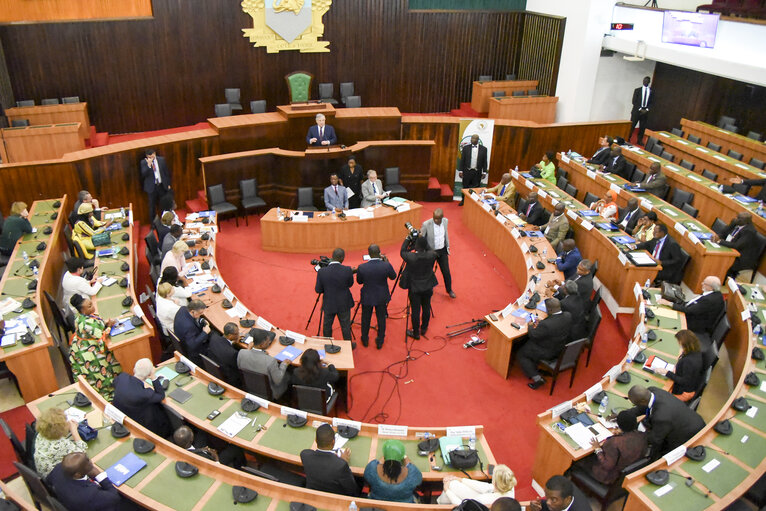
364;440;423;502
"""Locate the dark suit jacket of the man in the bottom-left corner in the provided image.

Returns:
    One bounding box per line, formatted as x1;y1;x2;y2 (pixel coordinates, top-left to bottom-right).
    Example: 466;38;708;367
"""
46;463;140;511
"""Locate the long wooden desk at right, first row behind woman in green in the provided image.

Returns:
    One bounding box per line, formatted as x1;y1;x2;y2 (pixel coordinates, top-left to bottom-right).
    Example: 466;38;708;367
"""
559;154;739;292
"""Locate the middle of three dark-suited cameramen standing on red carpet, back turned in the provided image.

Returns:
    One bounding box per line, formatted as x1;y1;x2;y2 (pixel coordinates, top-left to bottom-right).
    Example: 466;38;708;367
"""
356;244;396;349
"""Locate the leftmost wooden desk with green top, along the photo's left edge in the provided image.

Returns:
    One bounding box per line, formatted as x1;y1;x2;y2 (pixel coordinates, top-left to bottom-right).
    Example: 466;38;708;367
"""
0;195;68;401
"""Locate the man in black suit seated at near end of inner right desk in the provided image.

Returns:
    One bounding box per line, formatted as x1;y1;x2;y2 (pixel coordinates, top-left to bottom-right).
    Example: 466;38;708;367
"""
518;298;572;389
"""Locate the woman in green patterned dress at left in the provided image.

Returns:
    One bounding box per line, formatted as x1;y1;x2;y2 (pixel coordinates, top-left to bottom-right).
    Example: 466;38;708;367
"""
69;294;122;402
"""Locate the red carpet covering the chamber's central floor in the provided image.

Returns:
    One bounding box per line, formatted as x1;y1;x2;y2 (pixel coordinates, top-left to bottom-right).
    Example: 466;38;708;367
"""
134;202;626;499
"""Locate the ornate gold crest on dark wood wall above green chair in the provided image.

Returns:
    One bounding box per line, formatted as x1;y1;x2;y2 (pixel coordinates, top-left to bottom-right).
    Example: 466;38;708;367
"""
242;0;332;53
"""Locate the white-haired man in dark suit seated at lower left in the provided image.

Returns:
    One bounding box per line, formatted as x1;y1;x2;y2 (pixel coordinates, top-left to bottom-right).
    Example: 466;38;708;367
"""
112;358;173;438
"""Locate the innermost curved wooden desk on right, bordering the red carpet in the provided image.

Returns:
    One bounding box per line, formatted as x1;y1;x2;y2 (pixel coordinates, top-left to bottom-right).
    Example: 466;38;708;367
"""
463;191;564;378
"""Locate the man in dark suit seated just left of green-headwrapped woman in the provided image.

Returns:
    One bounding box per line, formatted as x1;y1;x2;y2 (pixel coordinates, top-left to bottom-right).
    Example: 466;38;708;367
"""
301;424;359;497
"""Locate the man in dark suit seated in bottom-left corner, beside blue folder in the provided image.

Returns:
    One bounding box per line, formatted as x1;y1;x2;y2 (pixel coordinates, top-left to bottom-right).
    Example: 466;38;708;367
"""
46;452;142;511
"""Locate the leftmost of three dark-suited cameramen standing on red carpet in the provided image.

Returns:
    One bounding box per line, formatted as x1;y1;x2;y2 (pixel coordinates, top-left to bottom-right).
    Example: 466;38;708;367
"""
314;248;356;348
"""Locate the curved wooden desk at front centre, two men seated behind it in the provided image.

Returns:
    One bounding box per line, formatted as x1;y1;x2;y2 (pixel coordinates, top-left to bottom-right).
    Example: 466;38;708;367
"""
261;201;423;254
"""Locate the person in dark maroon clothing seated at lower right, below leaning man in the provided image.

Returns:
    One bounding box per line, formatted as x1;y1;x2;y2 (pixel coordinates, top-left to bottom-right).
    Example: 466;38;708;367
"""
574;410;647;485
